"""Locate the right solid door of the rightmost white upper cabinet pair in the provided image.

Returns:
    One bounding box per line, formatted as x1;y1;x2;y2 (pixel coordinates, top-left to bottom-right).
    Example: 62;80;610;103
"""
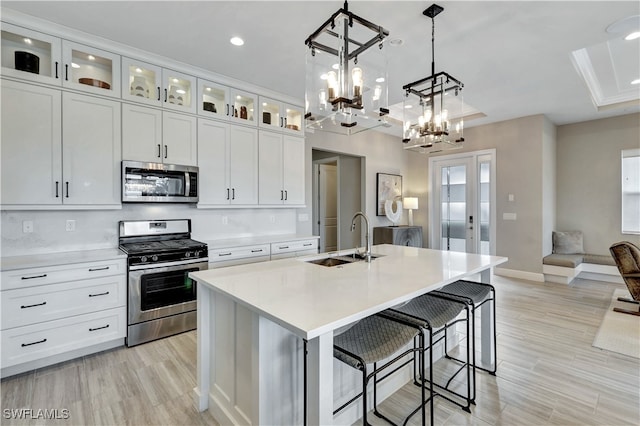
282;135;304;205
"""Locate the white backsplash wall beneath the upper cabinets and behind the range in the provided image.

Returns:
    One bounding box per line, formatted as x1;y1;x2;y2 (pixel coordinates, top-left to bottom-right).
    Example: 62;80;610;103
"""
1;204;296;256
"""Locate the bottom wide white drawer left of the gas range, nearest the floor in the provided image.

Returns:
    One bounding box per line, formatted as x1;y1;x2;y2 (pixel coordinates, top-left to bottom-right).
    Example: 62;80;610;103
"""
0;307;127;368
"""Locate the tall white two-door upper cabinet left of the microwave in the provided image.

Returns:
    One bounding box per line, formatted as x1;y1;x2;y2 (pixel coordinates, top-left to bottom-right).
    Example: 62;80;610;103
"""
2;80;121;209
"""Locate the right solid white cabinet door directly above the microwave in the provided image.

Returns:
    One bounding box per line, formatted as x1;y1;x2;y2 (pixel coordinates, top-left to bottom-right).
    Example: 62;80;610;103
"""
162;112;198;166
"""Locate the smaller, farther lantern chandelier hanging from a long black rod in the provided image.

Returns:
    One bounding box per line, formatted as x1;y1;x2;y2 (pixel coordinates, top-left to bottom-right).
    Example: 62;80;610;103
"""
402;4;464;153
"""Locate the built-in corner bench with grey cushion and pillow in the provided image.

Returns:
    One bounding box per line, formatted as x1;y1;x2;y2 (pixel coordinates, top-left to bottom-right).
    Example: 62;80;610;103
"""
542;231;623;284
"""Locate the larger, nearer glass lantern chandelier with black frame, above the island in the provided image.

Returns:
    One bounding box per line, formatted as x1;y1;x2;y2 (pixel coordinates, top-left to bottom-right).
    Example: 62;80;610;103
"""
305;1;389;135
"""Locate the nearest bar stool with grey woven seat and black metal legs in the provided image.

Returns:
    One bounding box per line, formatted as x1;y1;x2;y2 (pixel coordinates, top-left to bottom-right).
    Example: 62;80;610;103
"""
333;314;433;425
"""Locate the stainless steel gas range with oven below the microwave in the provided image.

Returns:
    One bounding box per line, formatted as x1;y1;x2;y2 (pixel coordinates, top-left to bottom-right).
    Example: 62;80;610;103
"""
119;219;209;346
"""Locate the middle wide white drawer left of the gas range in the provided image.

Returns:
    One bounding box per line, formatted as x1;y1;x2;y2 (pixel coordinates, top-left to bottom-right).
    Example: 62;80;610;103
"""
2;275;127;330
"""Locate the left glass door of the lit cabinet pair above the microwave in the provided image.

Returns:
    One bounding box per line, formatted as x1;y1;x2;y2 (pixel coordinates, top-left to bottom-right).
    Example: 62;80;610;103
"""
122;57;162;105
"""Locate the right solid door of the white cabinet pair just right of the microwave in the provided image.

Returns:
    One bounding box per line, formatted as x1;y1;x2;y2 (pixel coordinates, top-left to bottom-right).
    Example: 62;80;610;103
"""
229;126;258;205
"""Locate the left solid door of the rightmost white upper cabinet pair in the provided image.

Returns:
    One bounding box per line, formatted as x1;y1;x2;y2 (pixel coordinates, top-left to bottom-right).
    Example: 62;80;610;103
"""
258;131;284;204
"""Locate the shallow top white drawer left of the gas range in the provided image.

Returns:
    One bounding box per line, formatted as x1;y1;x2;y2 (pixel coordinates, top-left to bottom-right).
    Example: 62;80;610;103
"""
0;259;127;291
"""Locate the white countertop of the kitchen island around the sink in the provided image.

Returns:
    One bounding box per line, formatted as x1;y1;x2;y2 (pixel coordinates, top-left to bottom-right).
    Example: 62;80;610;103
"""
189;244;507;340
